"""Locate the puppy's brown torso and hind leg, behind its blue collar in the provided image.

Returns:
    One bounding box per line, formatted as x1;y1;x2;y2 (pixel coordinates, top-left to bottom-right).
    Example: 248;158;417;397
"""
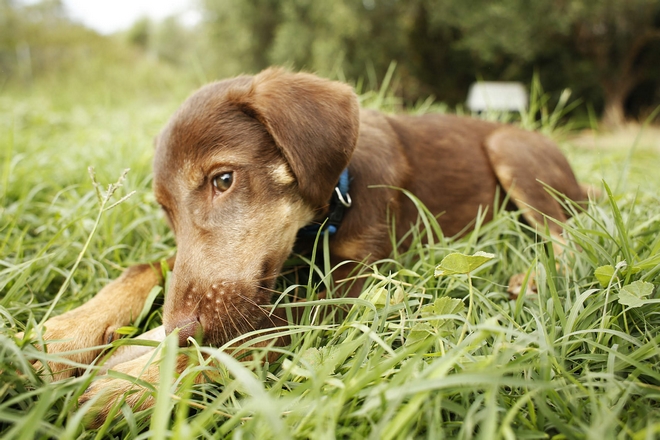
341;110;586;254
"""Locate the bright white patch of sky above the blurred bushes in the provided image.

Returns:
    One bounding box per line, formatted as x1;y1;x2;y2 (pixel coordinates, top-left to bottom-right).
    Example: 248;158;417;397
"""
63;0;199;34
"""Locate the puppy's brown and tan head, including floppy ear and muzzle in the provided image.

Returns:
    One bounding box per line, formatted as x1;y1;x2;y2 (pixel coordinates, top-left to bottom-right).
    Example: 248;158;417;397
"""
154;69;359;344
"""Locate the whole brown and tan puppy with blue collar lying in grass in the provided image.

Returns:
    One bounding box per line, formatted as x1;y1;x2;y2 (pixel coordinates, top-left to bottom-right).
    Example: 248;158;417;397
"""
23;68;586;424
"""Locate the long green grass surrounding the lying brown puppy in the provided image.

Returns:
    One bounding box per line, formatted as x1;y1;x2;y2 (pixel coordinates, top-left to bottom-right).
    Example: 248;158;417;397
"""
0;74;660;439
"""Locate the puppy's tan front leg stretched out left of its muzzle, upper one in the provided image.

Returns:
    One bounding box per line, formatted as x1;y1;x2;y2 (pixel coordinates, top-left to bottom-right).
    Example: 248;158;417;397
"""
18;257;174;380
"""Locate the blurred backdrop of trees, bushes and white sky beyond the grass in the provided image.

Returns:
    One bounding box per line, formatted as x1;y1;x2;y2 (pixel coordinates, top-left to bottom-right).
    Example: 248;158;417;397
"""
0;0;660;126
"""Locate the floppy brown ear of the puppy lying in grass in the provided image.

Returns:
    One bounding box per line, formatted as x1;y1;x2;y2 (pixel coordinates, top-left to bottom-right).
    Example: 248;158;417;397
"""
240;68;360;207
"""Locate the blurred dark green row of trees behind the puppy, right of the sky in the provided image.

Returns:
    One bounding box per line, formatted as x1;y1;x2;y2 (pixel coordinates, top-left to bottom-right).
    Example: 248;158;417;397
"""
203;0;660;123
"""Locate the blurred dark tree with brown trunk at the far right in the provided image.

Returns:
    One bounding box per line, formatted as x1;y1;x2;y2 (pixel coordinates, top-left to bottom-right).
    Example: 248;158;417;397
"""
426;0;660;125
